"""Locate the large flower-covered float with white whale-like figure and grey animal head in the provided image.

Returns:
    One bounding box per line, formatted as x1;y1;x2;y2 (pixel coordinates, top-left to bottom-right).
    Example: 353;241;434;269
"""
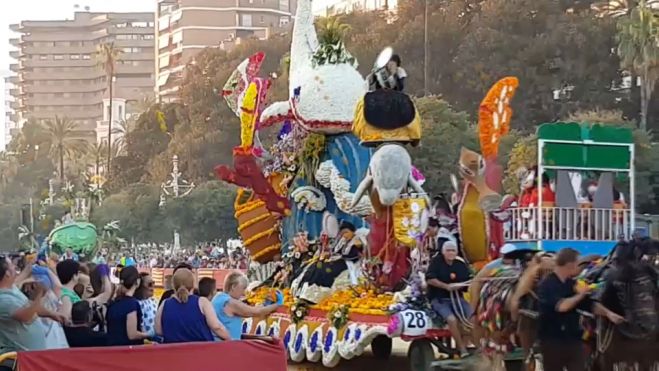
211;0;432;367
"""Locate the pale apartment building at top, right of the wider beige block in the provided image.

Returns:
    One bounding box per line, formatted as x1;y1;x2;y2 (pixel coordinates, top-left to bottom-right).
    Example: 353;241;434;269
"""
156;0;297;102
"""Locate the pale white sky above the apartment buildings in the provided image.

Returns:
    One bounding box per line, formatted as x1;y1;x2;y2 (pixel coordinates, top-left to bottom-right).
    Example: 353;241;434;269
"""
0;0;336;151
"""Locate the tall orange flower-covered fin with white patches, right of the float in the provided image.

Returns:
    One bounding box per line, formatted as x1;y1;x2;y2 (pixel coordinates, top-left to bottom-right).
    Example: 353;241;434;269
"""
478;77;519;158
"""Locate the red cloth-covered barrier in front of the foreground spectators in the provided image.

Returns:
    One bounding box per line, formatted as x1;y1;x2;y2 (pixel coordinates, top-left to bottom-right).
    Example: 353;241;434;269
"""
17;340;287;371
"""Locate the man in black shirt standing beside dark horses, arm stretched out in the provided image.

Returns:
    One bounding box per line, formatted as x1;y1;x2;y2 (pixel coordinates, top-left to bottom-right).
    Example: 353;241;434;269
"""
538;248;623;371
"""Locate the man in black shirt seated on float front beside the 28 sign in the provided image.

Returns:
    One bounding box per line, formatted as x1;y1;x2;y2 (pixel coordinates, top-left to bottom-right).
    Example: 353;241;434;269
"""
426;240;472;357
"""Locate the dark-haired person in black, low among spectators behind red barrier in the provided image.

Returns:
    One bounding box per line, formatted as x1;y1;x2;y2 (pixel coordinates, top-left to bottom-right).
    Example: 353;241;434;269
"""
64;300;108;348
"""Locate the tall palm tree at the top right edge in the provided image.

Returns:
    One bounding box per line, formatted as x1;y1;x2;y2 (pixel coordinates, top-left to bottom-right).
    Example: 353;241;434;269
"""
617;0;659;130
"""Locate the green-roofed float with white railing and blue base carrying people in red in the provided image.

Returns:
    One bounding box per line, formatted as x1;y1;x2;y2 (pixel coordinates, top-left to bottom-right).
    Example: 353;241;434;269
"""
504;122;636;255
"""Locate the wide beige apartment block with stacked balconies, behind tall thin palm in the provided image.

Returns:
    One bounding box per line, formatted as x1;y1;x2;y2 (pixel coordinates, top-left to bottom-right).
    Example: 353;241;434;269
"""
9;12;155;141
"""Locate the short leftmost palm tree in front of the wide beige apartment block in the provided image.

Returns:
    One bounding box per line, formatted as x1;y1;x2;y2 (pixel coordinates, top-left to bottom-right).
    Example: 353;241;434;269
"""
43;116;85;180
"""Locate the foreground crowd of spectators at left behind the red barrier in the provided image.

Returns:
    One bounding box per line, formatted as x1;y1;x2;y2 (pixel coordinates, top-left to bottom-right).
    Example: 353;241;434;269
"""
0;253;283;371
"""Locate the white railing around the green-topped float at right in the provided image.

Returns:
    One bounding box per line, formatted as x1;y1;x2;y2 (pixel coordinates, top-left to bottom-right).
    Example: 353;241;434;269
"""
504;207;632;241
